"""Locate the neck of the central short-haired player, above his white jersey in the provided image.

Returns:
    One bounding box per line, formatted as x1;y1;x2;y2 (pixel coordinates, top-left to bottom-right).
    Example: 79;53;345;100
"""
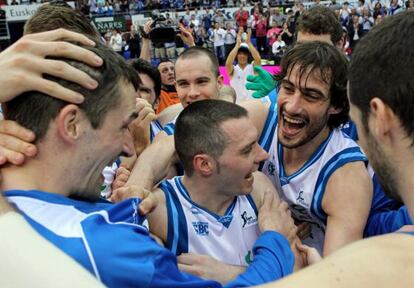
182;175;234;215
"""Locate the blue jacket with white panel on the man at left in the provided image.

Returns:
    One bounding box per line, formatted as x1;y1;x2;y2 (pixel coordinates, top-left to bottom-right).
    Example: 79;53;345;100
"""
5;190;294;287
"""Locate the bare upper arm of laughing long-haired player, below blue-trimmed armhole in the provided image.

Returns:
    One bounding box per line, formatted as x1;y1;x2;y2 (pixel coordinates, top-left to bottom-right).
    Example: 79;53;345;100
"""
322;161;373;255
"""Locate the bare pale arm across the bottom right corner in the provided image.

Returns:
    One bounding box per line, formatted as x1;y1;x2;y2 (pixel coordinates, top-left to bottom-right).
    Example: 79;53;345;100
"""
260;233;414;288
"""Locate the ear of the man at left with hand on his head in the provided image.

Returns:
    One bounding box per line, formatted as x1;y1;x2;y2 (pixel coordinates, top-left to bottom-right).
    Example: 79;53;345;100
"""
56;104;90;143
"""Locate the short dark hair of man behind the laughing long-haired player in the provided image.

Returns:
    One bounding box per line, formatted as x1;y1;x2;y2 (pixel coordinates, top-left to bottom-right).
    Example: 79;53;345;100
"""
296;6;342;45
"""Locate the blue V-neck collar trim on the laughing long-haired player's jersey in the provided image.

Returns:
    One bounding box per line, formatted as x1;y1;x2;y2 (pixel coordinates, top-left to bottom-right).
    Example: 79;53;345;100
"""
277;130;333;186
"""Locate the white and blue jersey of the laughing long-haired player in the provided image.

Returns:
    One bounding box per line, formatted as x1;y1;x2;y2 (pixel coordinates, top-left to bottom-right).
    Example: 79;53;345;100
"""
260;103;367;253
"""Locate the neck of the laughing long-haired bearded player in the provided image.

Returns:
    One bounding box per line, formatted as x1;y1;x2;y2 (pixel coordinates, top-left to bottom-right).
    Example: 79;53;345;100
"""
283;127;330;175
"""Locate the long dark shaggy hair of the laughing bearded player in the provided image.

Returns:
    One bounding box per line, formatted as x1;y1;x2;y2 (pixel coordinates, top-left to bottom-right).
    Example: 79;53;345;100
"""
276;41;349;128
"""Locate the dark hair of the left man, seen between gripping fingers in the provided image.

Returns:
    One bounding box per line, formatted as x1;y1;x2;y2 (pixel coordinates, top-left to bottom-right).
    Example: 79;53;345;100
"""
6;43;140;141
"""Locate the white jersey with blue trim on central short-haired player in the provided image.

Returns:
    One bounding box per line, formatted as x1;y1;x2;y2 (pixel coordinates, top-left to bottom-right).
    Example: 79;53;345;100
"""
160;177;260;266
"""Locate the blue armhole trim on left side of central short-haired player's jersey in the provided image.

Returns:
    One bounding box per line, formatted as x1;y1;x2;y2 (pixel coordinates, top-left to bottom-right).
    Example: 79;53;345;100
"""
159;181;188;255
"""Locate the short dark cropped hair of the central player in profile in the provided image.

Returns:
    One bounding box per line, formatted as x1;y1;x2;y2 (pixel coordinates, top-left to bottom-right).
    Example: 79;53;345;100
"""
174;100;248;176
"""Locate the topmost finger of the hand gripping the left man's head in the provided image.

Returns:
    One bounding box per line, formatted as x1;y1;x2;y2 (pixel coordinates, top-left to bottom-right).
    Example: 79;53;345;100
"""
24;29;95;46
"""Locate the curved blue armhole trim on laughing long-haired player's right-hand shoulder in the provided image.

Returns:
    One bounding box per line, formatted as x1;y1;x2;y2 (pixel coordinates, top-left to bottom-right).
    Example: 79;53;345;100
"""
311;147;368;223
